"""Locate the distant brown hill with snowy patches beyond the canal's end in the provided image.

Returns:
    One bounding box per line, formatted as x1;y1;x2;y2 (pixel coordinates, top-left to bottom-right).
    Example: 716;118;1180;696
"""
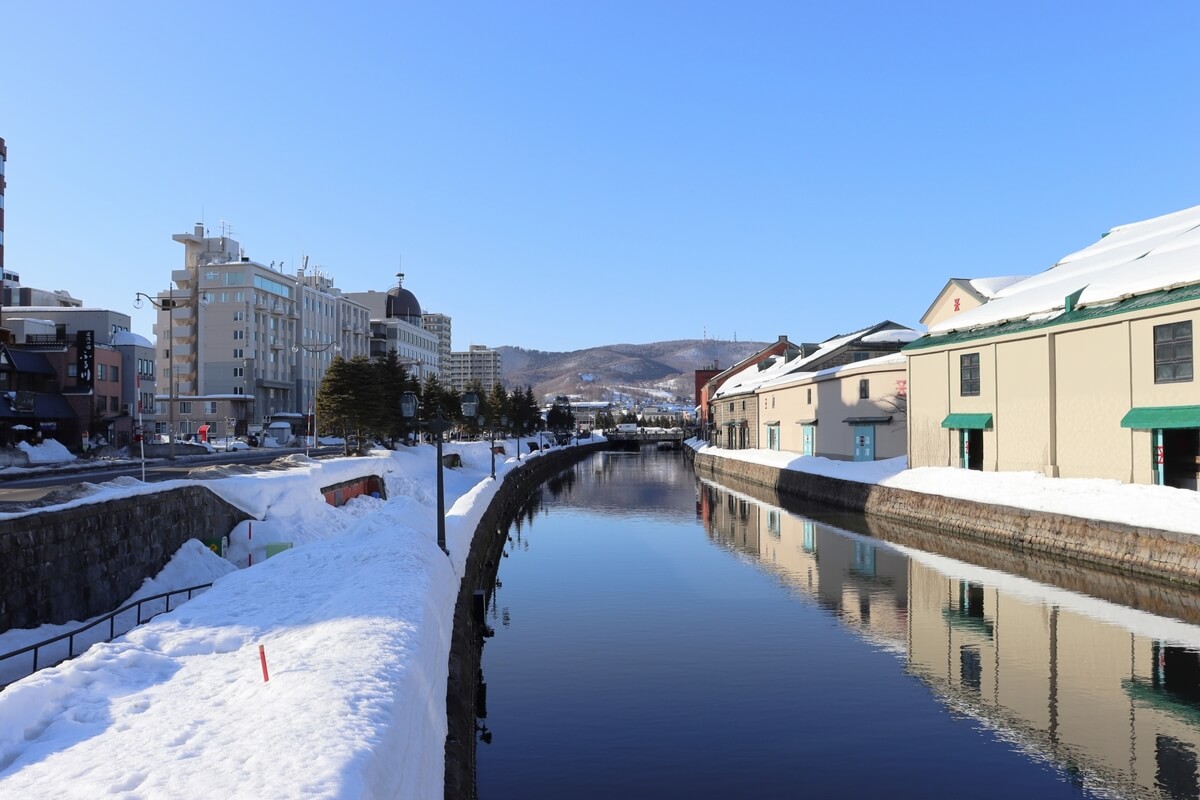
498;339;767;405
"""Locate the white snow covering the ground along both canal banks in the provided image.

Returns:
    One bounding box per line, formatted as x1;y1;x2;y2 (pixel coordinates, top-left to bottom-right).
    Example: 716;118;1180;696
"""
0;443;1200;799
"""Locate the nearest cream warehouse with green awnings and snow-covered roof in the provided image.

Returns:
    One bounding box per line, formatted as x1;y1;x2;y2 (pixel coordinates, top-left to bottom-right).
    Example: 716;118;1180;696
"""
905;206;1200;489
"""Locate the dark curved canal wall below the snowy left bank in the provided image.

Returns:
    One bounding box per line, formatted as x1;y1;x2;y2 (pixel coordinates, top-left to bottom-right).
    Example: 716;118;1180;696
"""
445;443;605;800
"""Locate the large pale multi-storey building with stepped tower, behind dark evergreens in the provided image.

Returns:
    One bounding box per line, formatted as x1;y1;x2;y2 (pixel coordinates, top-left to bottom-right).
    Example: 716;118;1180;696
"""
154;224;370;435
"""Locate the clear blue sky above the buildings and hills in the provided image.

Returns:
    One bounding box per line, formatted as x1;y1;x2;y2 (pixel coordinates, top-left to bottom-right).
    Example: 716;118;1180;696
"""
0;0;1200;350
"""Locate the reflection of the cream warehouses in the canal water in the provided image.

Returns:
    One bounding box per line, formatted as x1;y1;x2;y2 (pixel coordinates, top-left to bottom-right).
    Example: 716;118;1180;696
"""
696;481;1200;799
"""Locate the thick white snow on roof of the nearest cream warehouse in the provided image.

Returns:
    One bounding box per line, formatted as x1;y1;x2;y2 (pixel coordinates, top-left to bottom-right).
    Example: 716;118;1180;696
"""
929;206;1200;333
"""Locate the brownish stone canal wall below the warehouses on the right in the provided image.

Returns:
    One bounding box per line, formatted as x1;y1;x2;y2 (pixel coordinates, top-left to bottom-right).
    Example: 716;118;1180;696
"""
688;450;1200;585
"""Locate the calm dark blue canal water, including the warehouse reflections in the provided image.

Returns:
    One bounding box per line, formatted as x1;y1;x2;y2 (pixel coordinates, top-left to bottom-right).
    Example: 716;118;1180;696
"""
476;450;1200;800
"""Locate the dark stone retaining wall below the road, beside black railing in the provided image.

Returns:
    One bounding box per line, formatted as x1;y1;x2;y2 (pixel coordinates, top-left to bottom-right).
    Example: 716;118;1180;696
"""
0;486;250;631
